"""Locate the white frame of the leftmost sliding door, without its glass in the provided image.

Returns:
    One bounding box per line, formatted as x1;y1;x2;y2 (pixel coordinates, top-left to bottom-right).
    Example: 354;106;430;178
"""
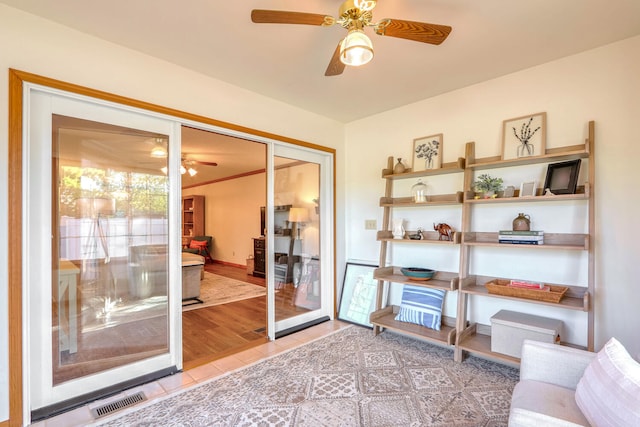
22;83;182;422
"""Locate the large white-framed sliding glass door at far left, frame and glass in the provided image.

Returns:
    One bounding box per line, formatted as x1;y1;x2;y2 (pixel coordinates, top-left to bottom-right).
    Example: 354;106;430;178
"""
23;89;181;419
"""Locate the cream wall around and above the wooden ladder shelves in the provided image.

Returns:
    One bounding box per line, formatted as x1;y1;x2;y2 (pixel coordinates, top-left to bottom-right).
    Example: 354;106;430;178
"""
345;37;640;357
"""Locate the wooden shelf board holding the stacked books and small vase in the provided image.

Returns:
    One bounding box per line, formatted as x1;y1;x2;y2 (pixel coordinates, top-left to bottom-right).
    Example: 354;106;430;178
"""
462;232;589;251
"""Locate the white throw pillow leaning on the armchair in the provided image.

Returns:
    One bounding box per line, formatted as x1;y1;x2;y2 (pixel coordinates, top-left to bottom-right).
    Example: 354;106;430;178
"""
576;338;640;427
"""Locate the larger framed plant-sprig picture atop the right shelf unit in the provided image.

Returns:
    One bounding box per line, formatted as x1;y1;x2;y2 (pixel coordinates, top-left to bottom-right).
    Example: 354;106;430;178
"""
502;113;547;160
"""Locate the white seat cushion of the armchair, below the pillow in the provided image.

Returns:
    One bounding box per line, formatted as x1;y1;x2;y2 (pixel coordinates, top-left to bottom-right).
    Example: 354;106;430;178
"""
509;380;589;427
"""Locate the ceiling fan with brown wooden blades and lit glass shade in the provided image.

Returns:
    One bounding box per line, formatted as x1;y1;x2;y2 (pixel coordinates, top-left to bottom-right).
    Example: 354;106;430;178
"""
251;0;451;76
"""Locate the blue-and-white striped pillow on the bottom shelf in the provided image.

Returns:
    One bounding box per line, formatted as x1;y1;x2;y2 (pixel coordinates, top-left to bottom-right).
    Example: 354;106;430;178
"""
395;285;445;331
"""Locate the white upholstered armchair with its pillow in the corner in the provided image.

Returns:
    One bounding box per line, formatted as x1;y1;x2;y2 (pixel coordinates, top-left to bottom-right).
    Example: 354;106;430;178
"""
509;338;640;427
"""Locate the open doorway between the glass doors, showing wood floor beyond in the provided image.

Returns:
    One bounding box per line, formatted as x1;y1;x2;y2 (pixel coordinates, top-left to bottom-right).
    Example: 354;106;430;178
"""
181;125;267;369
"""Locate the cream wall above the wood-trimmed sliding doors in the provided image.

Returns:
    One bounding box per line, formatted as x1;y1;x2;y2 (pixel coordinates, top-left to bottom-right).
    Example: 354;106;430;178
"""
0;5;344;421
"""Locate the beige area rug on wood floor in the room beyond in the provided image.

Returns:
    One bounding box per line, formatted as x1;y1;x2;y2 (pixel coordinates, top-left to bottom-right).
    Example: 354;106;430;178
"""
182;271;267;311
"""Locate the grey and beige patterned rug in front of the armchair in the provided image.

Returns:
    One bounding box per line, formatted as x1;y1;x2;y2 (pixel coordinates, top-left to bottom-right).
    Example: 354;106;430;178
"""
100;326;518;427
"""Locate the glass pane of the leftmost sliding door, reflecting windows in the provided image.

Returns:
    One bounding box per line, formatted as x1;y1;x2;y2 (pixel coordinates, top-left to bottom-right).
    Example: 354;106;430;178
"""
51;115;169;386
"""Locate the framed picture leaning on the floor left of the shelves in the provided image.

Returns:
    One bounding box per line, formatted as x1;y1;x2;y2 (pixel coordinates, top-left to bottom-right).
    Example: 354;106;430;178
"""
338;262;378;328
